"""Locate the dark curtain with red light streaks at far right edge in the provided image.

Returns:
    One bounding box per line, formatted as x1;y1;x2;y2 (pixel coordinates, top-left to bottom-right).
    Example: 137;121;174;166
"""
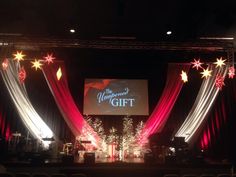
200;79;236;151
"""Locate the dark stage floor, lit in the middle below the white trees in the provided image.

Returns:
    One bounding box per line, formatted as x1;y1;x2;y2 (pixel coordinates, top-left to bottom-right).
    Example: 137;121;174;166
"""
3;151;233;177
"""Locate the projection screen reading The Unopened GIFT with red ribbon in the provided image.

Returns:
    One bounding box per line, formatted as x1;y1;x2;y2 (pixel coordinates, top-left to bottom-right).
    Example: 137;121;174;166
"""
83;79;149;115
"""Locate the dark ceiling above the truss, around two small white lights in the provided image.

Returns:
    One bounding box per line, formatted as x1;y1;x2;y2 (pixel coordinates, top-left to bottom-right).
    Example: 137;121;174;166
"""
0;0;236;41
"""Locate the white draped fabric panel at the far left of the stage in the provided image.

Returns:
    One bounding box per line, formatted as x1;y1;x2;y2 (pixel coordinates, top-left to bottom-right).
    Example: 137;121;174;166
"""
0;59;54;146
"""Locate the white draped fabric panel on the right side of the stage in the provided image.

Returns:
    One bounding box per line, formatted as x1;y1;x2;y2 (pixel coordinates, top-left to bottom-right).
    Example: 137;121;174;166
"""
175;65;228;145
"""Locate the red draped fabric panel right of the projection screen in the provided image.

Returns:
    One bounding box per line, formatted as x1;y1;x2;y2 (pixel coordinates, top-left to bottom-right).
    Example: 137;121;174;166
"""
138;63;190;144
